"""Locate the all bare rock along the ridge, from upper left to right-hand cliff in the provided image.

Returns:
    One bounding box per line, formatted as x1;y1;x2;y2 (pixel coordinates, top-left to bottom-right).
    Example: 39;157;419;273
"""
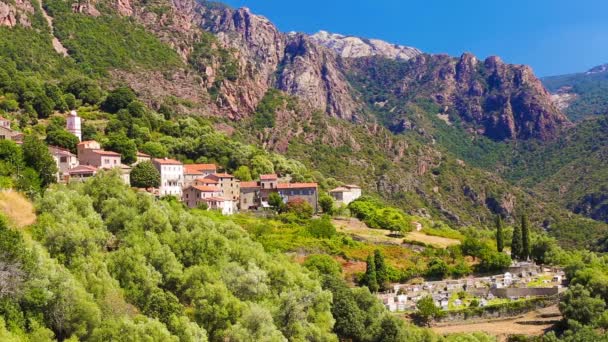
17;0;568;140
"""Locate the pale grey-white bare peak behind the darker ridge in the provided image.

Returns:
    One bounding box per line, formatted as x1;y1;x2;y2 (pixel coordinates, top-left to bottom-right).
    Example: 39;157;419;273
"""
310;31;422;60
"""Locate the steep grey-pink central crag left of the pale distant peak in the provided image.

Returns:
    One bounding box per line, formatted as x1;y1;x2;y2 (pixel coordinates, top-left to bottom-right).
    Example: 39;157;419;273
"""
201;7;359;120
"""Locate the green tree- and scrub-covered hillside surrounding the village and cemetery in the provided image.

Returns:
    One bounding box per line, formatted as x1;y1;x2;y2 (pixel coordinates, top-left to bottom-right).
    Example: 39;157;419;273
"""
0;0;608;342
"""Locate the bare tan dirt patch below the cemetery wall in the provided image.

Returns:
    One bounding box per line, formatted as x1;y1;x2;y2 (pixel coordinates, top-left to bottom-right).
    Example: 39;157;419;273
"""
432;305;561;342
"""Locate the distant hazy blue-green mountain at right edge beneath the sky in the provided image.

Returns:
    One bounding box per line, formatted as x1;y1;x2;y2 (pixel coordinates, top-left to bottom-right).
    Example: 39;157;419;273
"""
542;64;608;121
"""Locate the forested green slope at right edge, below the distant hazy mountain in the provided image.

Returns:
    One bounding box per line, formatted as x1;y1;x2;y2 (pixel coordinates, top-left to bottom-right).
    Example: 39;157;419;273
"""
503;116;608;226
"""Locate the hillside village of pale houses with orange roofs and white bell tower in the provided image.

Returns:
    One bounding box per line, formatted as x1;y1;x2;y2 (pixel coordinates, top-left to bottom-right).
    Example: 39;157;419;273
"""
0;111;361;215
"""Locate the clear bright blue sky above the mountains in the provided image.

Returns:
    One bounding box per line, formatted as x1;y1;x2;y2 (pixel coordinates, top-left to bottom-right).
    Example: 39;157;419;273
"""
218;0;608;76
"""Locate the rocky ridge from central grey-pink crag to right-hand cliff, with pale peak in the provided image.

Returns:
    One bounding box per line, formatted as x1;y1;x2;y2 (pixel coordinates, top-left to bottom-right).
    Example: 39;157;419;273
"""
196;3;568;140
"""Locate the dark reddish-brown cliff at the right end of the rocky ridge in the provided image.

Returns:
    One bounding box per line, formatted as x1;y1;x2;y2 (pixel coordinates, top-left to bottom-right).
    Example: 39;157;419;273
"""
349;53;568;140
